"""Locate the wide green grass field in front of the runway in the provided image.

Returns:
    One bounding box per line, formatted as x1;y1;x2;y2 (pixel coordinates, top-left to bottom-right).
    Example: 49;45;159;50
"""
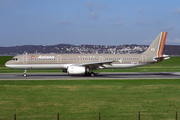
0;79;180;120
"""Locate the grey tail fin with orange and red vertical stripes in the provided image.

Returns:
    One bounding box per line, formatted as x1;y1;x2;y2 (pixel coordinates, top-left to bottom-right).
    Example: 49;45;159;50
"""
143;32;167;58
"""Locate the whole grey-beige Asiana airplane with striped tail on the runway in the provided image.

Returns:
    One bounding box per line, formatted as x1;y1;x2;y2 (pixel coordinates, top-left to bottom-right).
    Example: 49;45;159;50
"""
5;32;170;77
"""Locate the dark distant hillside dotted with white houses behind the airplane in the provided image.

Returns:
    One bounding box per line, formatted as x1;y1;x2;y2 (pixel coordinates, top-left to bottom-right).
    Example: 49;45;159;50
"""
0;44;180;55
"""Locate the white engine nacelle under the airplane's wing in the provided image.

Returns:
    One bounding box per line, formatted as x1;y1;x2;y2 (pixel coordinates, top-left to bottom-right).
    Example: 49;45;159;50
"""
67;66;88;74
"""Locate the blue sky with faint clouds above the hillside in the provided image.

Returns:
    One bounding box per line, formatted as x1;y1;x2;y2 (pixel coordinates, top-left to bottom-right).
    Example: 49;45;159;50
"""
0;0;180;46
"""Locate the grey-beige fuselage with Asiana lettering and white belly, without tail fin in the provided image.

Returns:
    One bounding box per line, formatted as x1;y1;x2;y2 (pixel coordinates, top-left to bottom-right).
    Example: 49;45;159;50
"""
5;54;153;70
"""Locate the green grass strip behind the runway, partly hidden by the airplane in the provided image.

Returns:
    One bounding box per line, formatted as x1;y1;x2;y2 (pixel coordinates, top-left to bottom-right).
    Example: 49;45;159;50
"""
0;56;180;73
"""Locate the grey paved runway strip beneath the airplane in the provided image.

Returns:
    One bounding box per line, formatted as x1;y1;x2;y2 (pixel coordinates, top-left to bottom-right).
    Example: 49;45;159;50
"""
0;72;180;80
